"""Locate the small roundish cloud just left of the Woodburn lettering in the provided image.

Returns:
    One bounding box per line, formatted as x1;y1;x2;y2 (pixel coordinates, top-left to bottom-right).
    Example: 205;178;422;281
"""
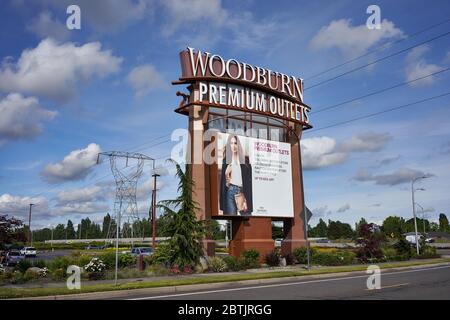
127;64;167;98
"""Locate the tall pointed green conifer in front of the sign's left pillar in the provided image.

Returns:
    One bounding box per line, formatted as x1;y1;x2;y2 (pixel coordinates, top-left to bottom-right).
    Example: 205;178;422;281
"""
158;160;207;267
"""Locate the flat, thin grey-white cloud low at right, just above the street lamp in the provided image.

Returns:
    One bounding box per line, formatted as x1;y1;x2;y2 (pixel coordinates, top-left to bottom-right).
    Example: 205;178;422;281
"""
353;168;432;186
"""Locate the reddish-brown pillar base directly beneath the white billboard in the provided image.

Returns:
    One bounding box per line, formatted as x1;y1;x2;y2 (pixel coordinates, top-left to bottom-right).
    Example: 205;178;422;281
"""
229;218;275;262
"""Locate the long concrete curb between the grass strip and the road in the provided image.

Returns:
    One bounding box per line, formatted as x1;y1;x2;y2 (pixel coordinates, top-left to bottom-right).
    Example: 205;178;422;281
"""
10;262;450;300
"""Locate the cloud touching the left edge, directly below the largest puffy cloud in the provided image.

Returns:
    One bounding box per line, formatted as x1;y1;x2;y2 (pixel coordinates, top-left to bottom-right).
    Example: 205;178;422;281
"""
0;93;57;142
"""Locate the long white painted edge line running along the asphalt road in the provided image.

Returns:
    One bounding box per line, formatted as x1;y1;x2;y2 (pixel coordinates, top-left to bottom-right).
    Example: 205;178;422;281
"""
127;265;450;300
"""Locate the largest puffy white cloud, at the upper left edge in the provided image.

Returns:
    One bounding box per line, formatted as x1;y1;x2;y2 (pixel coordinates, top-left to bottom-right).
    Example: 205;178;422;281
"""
0;39;122;101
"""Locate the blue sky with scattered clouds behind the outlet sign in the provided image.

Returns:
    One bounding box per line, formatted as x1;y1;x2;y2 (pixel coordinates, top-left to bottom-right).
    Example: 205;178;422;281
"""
0;0;450;228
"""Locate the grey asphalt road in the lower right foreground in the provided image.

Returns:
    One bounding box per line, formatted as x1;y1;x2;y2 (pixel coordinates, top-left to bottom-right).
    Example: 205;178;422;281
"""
118;265;450;301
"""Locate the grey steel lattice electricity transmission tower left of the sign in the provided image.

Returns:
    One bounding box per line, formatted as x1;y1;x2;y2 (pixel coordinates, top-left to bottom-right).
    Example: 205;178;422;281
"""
97;151;155;241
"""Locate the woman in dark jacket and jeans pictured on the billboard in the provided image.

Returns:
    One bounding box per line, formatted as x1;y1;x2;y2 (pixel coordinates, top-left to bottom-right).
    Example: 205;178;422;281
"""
220;134;253;215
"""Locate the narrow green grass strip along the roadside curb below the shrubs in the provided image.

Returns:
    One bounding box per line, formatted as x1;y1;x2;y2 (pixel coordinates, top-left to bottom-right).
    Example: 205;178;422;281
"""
0;258;450;299
